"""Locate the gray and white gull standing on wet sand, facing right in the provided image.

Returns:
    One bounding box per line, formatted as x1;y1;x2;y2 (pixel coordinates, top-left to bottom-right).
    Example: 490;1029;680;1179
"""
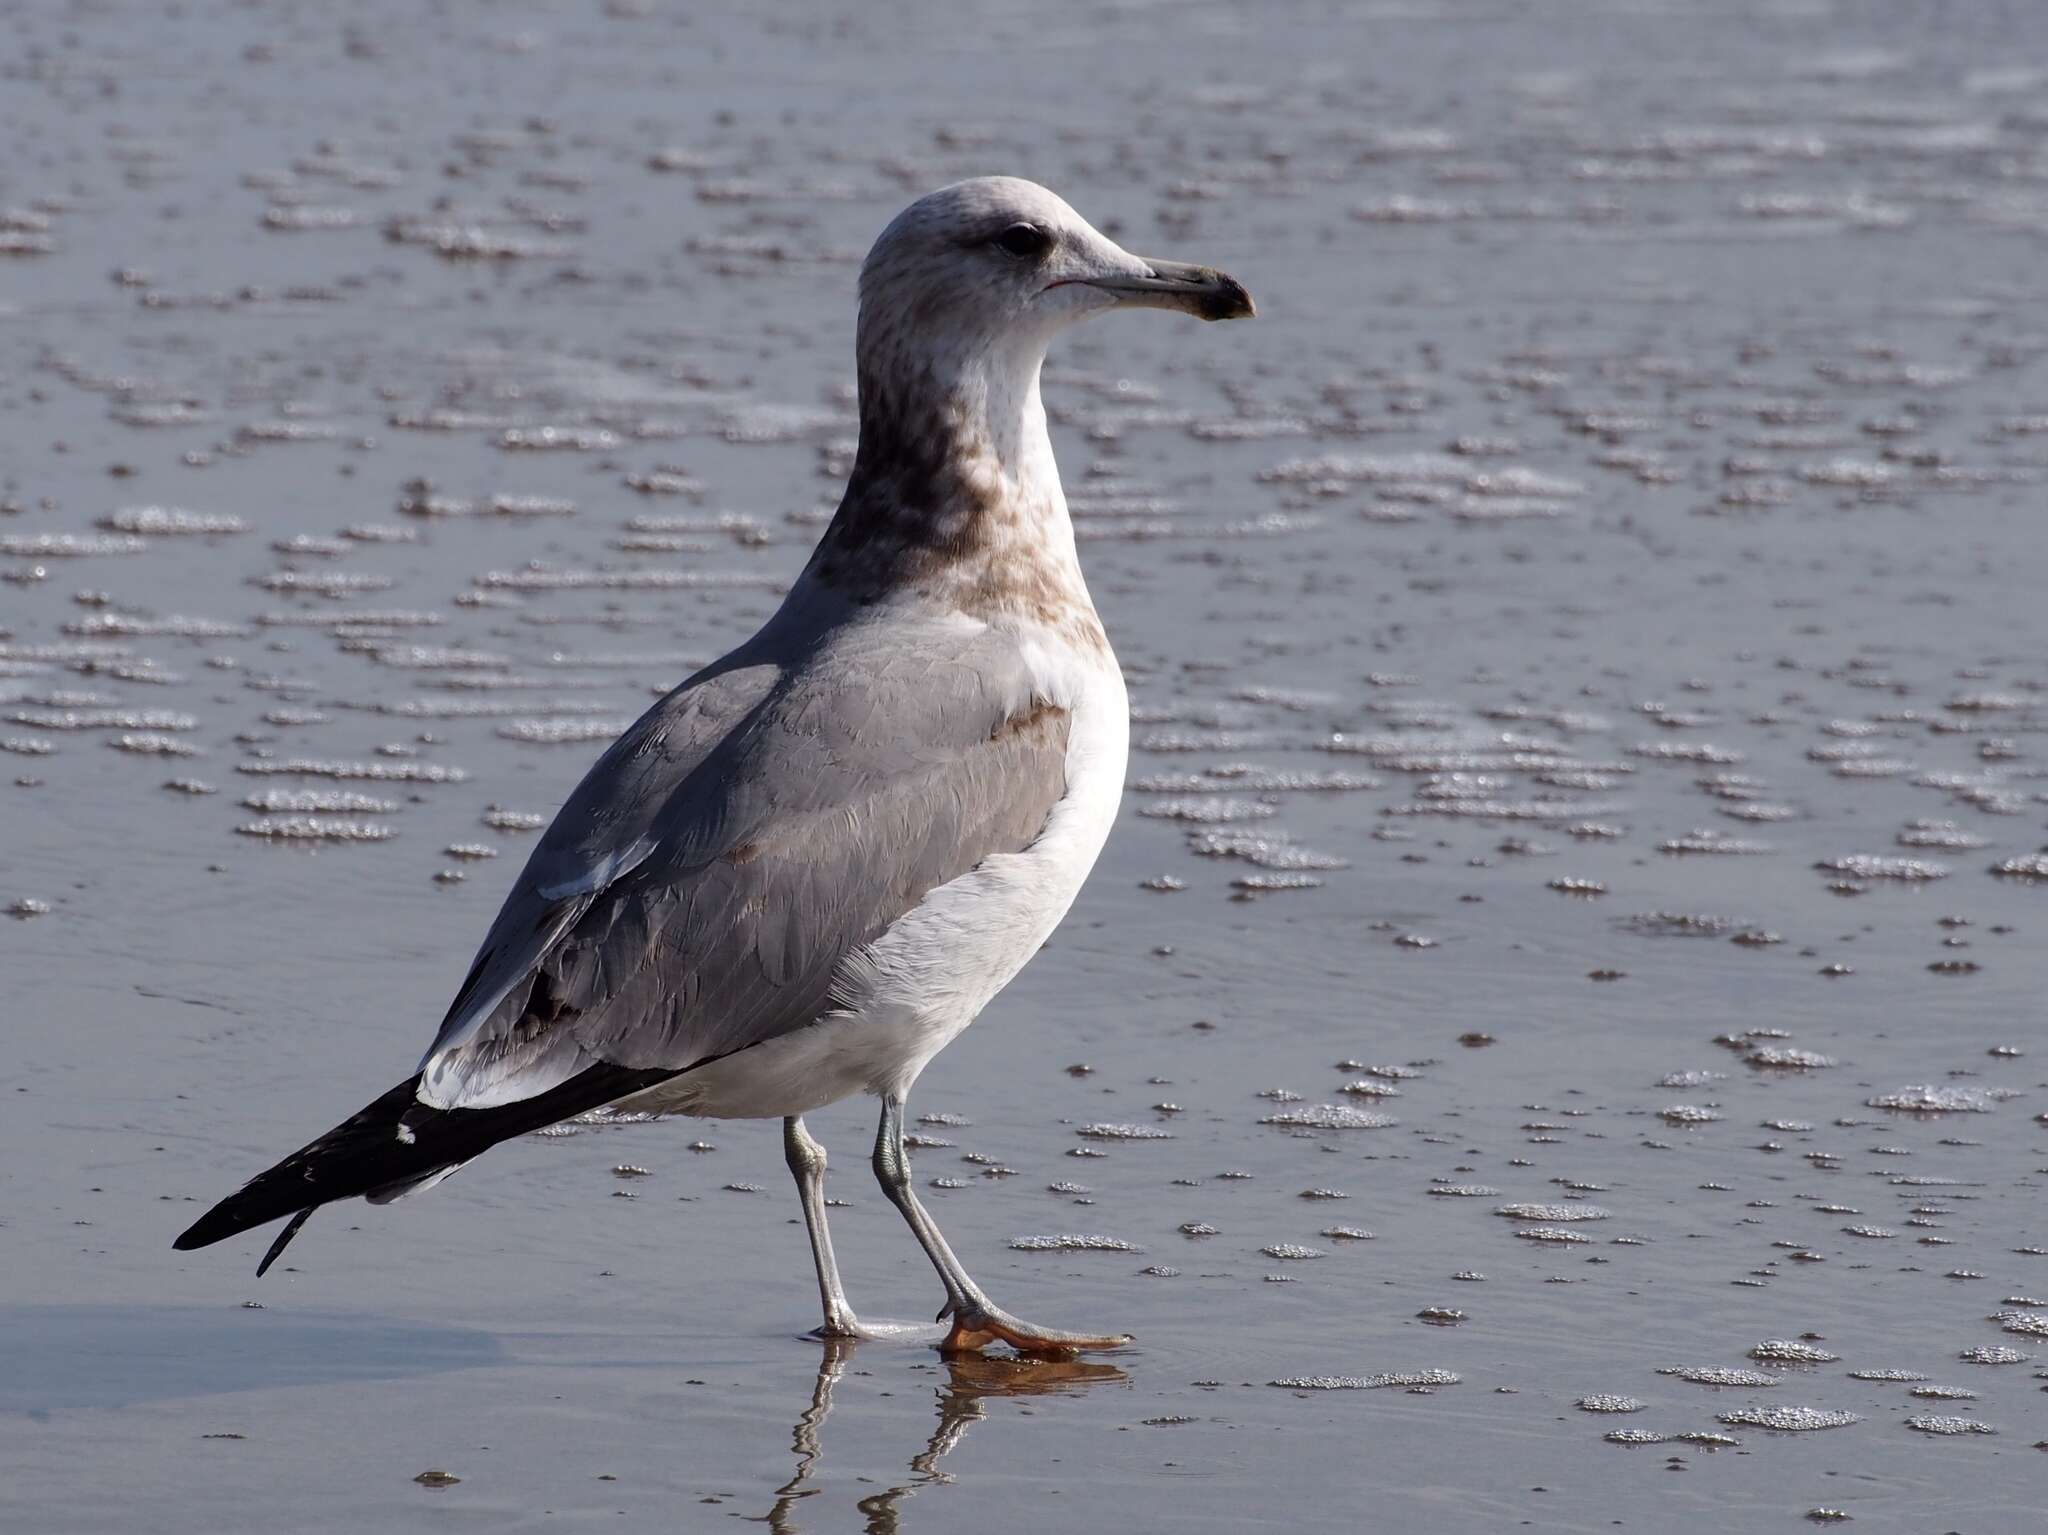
176;176;1253;1355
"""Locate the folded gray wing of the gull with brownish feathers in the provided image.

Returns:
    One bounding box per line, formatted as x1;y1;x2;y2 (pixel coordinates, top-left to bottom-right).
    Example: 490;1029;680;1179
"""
407;628;1067;1107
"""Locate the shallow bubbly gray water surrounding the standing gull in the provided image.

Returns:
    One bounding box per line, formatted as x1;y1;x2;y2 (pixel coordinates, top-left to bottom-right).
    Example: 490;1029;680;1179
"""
0;0;2048;1535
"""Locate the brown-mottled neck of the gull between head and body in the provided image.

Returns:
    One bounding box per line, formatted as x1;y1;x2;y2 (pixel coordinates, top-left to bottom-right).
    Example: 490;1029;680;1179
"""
805;329;1102;641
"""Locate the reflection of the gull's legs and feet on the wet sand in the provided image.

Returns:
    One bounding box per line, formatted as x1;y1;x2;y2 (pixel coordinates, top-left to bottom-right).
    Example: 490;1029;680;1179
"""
764;1339;1126;1535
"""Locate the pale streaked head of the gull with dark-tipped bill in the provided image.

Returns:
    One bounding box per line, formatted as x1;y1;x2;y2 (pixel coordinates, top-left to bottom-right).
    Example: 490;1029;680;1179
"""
860;176;1255;364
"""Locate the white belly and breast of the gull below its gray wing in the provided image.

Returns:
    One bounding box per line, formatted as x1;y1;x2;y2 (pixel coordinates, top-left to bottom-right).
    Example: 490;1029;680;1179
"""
623;642;1130;1117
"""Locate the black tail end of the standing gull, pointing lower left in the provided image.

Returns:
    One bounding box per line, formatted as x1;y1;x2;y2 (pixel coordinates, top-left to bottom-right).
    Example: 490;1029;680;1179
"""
172;1066;674;1275
